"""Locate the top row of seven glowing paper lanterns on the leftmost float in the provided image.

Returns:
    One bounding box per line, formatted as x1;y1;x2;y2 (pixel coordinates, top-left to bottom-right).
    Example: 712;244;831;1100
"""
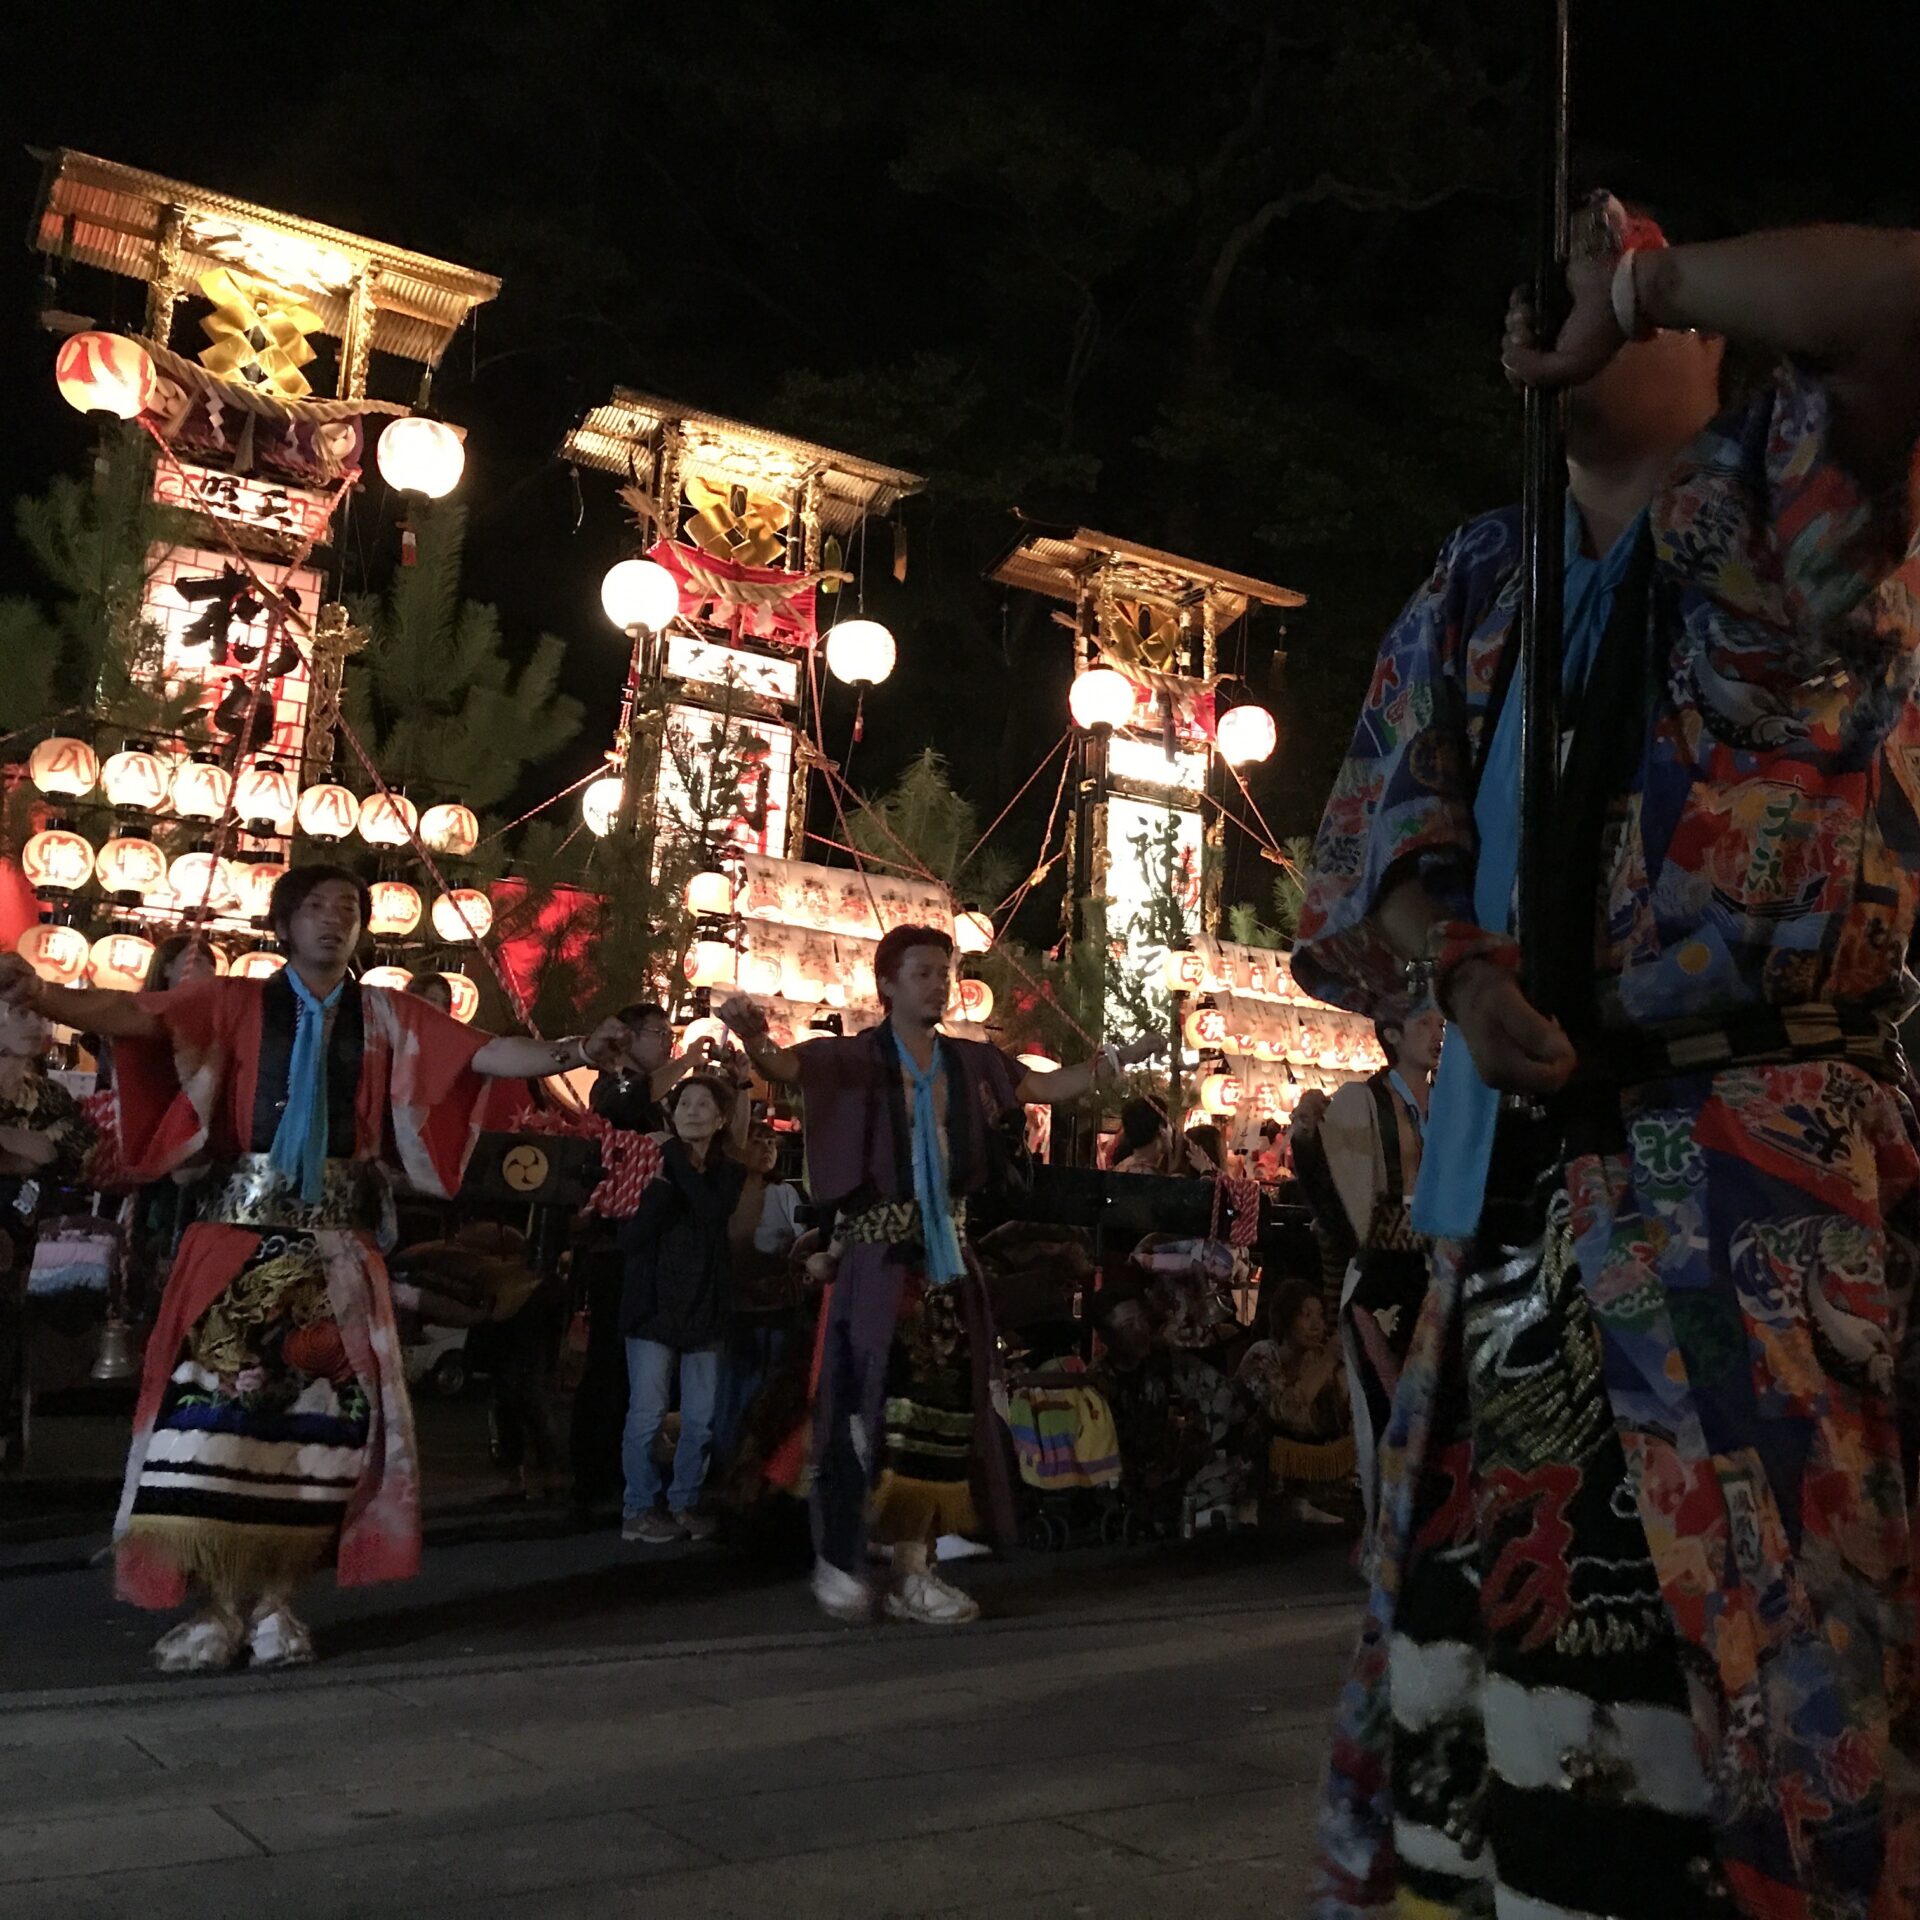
27;733;480;860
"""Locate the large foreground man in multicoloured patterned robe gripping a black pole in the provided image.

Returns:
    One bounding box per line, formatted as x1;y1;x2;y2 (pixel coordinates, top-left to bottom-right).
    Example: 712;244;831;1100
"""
1294;196;1920;1920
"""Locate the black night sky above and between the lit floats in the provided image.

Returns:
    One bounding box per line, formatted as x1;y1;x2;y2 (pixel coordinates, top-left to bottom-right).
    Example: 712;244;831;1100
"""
0;0;1920;935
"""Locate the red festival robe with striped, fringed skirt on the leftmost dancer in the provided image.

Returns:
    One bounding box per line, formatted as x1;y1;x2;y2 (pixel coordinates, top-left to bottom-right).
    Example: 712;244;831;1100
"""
113;975;488;1607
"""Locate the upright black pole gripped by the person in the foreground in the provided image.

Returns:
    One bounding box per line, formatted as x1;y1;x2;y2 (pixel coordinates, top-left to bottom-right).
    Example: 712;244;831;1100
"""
1515;0;1572;1012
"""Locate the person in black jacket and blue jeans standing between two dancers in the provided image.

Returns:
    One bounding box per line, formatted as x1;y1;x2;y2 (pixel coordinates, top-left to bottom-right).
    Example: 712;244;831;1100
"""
620;1073;747;1546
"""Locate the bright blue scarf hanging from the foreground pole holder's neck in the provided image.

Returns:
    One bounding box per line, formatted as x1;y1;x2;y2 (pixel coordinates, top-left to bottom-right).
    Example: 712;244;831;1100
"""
1413;493;1647;1240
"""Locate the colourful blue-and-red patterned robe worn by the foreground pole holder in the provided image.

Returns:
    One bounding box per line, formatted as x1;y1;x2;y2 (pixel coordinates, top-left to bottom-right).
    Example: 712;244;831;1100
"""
1294;369;1920;1920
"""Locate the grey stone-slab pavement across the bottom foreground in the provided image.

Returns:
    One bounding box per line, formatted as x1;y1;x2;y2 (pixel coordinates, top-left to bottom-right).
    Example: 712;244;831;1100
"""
0;1571;1357;1920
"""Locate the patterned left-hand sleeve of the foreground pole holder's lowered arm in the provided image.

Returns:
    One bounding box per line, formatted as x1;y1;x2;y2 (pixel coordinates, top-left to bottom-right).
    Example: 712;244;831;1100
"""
1294;515;1513;1012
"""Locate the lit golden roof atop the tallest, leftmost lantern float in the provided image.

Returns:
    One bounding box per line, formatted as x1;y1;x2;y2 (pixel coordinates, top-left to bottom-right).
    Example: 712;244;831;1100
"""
29;148;499;365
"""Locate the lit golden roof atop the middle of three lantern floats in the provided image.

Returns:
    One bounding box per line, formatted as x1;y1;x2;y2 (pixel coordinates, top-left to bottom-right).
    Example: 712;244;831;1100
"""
561;386;927;534
